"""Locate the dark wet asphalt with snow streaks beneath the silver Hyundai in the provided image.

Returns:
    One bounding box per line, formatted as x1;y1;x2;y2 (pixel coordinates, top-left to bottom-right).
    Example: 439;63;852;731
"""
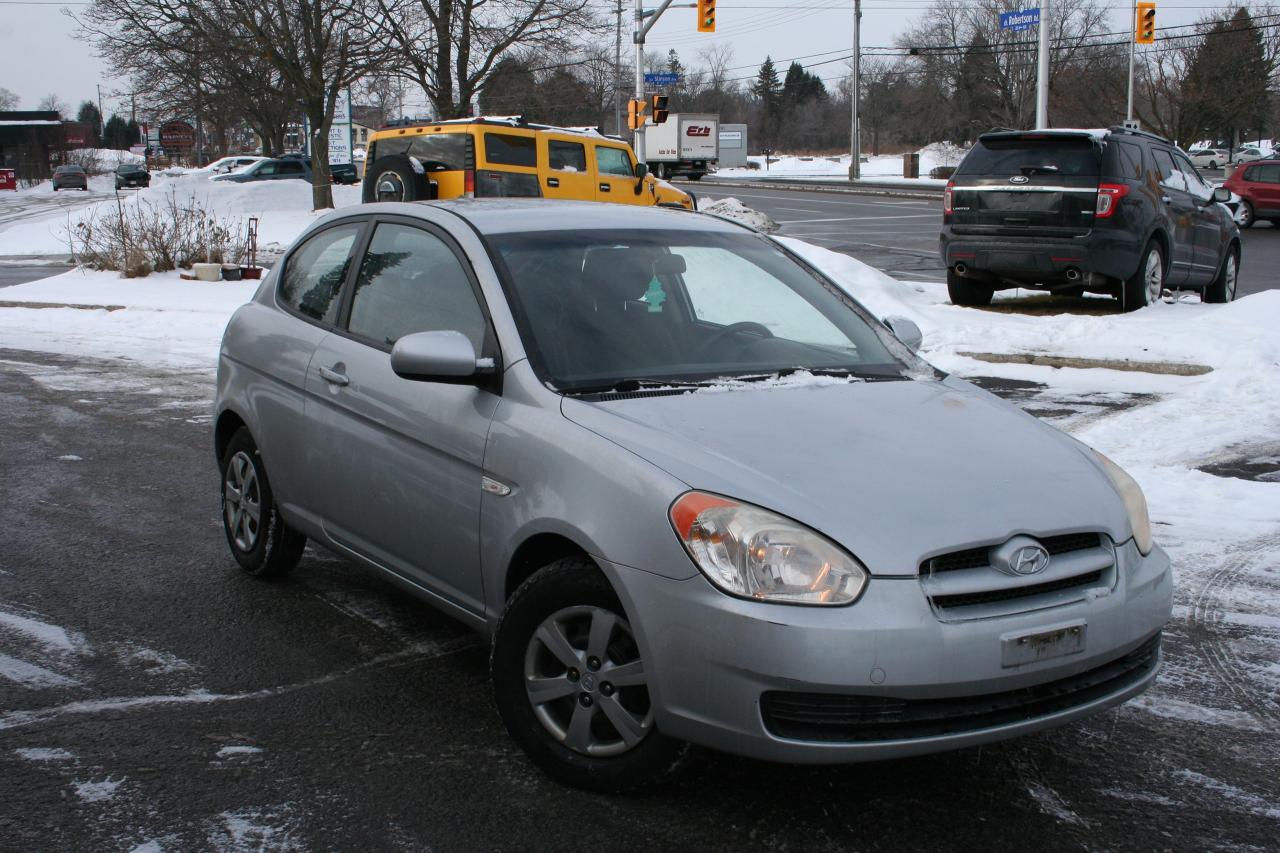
0;350;1280;852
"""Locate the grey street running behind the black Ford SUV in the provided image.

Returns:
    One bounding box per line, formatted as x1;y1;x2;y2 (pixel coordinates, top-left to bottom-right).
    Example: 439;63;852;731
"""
685;183;1280;296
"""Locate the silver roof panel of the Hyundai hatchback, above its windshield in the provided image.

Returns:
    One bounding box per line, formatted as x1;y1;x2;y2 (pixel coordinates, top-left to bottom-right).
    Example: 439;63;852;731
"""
345;199;754;234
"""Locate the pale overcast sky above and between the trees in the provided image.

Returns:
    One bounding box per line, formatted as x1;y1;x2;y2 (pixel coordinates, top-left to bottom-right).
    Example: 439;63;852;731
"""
0;0;1259;115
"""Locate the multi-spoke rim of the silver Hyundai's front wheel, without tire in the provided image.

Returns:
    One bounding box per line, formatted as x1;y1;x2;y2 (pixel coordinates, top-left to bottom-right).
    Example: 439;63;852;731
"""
524;606;653;758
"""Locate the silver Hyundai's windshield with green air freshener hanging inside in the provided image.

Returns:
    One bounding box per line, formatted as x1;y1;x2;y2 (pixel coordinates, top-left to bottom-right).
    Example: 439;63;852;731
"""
490;231;915;393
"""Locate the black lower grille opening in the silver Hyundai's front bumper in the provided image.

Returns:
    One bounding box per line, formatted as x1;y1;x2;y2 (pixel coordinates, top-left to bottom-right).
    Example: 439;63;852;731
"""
760;633;1160;743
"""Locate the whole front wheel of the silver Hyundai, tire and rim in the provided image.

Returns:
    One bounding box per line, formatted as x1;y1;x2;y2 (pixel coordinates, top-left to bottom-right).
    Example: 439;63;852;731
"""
490;557;685;793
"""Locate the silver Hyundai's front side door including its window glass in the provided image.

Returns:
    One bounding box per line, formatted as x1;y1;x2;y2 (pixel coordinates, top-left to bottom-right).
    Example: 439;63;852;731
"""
307;218;499;612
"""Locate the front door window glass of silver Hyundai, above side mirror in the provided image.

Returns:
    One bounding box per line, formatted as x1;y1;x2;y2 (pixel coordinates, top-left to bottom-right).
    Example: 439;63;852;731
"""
347;223;488;352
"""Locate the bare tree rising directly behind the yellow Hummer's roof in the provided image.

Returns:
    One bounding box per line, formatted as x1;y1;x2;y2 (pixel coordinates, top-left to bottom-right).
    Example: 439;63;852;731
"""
371;0;602;119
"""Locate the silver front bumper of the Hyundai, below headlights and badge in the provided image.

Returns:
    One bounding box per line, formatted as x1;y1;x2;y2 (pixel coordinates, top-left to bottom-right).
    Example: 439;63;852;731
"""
604;542;1172;763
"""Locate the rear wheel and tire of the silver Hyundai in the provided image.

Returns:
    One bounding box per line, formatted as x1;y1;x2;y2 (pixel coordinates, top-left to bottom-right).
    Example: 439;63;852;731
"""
219;427;307;578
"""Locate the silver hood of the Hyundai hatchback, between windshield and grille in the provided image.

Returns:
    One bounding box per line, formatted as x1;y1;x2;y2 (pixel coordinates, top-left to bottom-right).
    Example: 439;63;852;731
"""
562;379;1129;576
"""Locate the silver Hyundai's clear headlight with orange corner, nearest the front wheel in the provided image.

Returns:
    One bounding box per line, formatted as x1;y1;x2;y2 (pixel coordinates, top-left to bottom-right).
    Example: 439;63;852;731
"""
671;492;867;605
